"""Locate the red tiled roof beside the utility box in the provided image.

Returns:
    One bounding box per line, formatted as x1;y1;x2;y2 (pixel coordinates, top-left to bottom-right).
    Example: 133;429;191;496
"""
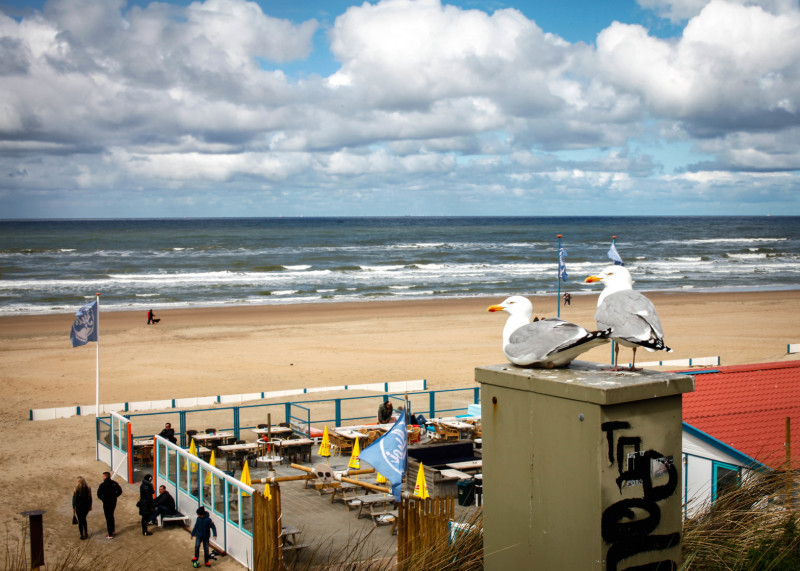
683;361;800;469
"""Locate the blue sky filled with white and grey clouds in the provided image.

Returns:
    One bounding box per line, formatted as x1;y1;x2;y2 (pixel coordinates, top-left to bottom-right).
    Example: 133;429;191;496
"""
0;0;800;218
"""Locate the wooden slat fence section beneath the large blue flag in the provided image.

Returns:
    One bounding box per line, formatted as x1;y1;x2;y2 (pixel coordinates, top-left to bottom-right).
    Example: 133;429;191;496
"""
397;497;456;564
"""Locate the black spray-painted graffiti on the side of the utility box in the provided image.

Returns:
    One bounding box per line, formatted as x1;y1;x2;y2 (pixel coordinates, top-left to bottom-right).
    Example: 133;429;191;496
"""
601;421;680;571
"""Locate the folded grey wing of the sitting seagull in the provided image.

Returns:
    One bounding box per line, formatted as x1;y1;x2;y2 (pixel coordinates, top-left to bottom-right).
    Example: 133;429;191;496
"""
510;318;608;367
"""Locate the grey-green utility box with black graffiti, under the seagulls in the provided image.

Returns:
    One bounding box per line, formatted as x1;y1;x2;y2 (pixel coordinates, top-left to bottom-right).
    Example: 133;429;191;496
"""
475;361;694;571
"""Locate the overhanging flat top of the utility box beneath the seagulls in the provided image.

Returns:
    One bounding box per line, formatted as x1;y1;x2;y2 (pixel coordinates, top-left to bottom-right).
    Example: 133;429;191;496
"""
475;361;694;405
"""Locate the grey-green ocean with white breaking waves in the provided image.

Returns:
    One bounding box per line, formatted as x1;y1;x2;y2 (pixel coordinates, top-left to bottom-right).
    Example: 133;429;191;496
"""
0;216;800;315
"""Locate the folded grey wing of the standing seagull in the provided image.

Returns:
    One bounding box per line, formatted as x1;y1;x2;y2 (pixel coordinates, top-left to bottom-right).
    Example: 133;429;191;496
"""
594;290;664;345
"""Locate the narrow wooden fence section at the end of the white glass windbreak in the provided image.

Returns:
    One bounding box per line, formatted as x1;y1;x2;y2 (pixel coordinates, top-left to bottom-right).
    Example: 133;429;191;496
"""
253;483;283;571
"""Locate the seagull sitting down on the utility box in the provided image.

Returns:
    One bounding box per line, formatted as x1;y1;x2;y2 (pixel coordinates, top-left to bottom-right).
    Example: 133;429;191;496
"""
489;295;611;369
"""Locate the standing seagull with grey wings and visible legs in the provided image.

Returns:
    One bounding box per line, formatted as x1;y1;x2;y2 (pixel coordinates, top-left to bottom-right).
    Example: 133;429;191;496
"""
585;266;672;371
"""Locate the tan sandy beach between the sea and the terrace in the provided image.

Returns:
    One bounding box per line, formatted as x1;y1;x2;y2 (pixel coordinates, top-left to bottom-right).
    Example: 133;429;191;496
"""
0;291;800;569
